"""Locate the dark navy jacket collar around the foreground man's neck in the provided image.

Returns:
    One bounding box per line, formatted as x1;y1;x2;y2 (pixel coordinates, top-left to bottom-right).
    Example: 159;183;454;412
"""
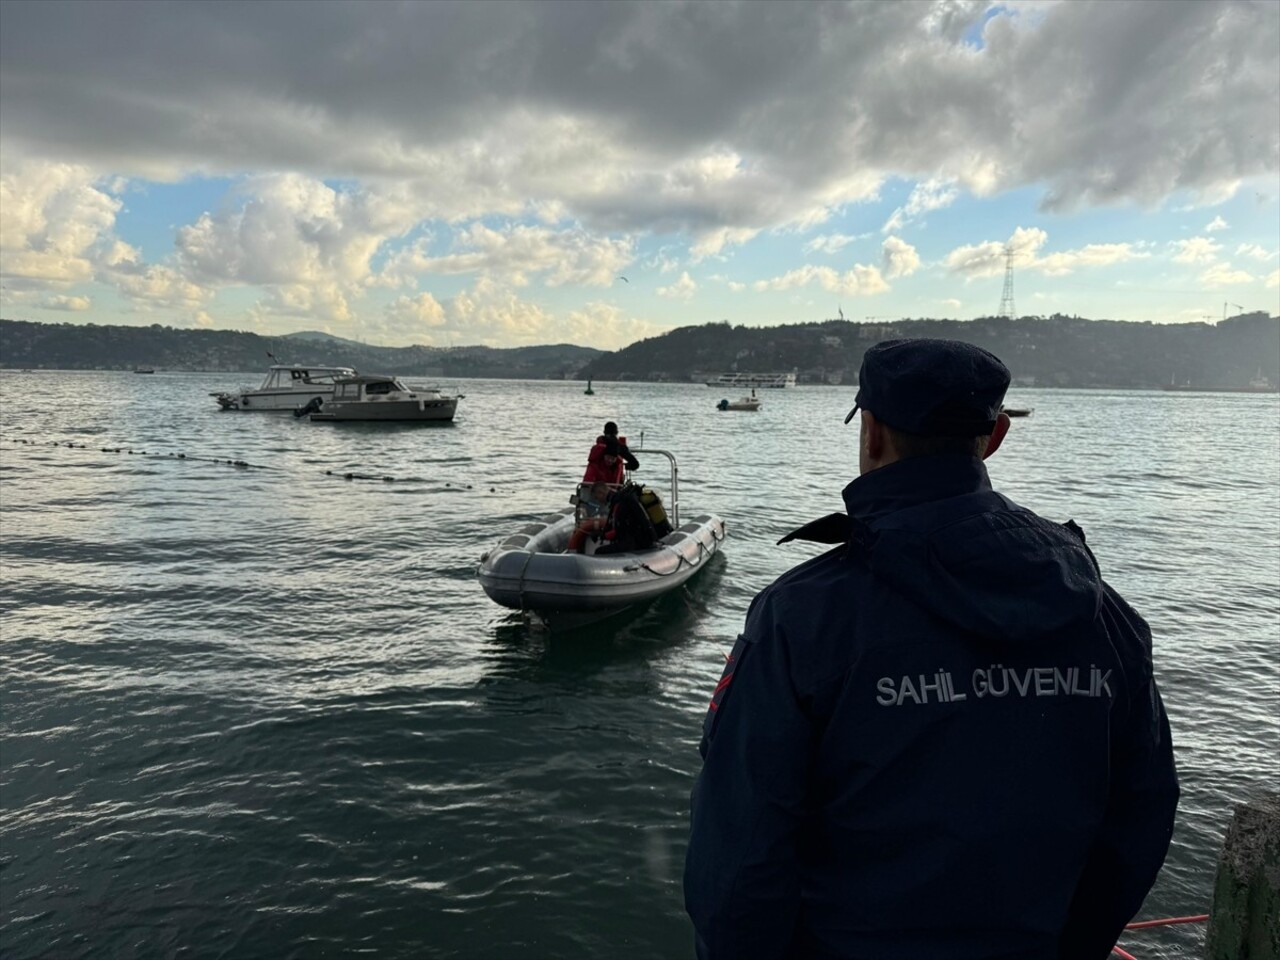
844;454;991;524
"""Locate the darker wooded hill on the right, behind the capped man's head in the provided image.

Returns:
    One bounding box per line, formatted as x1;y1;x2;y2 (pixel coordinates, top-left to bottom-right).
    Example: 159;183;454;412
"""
582;314;1280;389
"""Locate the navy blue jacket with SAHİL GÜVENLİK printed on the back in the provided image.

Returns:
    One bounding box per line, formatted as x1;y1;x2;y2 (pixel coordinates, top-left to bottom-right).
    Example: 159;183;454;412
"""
685;457;1178;960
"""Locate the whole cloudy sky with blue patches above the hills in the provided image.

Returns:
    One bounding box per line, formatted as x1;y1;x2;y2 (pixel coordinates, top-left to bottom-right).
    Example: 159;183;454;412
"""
0;0;1280;348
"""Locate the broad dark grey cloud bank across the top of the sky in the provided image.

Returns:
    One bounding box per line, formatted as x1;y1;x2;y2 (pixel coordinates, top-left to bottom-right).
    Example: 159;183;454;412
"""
0;0;1280;236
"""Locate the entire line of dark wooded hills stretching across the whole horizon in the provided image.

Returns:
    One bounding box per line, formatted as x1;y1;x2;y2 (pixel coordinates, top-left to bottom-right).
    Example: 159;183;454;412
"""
0;314;1280;389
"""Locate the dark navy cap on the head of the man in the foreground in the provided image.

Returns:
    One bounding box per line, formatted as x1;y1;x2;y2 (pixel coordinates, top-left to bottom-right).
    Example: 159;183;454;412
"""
845;339;1009;436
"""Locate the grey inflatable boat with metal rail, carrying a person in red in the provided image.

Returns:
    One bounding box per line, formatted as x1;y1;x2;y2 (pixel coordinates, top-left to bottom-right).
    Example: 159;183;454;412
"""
476;449;726;625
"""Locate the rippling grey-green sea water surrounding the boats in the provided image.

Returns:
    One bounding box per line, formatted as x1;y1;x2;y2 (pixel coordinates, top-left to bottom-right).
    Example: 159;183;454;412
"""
0;371;1280;960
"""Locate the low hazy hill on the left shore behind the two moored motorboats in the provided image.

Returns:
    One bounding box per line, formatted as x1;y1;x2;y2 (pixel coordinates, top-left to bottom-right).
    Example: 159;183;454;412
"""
0;320;600;380
